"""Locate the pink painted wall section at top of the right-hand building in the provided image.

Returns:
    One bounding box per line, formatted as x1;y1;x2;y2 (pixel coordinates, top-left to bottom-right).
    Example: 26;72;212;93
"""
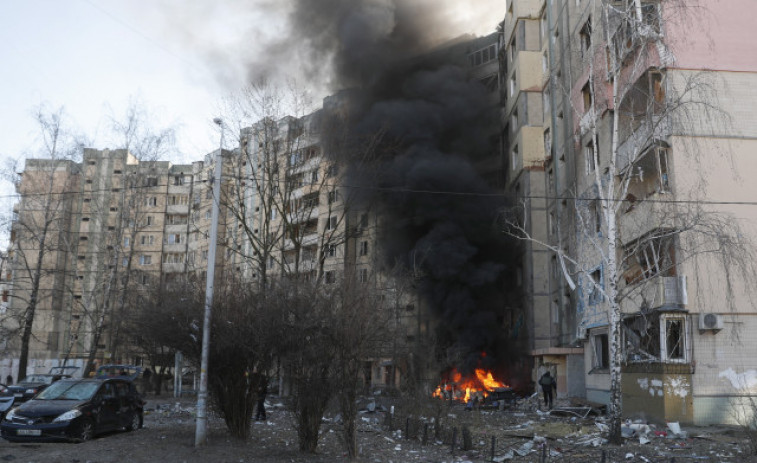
663;0;757;71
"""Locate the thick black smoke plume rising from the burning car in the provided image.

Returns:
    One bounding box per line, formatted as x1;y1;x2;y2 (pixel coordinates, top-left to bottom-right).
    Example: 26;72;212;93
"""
292;0;519;380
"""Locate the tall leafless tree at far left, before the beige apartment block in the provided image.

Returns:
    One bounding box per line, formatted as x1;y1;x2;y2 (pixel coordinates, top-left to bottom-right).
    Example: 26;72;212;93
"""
6;107;80;380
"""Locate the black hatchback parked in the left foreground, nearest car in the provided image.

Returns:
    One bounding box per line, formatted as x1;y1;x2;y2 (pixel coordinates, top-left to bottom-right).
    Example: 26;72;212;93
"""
0;378;144;442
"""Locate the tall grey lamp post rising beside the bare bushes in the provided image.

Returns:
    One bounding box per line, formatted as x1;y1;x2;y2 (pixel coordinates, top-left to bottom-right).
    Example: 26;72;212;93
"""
195;117;223;447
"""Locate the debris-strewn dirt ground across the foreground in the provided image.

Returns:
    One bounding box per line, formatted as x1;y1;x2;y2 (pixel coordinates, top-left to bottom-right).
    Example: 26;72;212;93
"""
0;397;757;463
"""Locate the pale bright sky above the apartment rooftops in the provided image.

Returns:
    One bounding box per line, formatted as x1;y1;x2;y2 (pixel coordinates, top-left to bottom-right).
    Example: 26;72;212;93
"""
0;0;505;180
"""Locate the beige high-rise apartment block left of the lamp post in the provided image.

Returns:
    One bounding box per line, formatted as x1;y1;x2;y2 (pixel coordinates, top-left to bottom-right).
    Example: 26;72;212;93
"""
0;149;228;376
